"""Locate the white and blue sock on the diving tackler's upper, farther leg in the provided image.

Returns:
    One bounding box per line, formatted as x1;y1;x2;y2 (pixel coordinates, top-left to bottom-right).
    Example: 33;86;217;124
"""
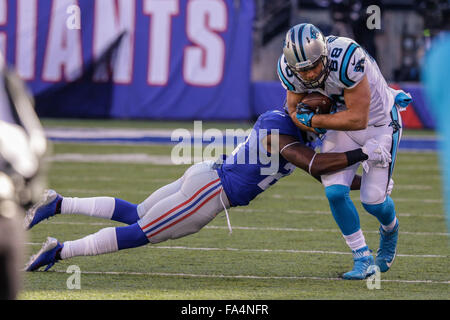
61;197;139;224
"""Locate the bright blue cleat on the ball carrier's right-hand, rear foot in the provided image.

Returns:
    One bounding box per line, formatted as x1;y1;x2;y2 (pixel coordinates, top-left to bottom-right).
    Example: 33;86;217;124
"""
375;221;399;272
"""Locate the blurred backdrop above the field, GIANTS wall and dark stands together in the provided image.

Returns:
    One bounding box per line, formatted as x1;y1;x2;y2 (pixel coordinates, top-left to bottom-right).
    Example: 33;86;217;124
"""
0;0;450;129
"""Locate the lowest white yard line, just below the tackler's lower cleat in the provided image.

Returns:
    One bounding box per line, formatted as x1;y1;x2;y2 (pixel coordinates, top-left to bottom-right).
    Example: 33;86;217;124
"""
44;270;450;284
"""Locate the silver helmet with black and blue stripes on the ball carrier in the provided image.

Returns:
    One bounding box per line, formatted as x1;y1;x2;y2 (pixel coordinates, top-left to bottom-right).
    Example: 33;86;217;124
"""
283;23;330;89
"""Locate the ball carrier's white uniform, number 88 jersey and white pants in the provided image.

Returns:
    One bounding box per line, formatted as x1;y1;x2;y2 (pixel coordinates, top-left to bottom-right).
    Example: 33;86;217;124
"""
277;36;402;204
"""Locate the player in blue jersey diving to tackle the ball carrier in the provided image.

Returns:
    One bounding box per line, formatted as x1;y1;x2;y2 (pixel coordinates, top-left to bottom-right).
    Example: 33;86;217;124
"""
24;111;390;271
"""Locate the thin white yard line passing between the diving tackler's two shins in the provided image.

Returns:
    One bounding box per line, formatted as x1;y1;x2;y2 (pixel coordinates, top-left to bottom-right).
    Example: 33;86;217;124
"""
43;221;450;237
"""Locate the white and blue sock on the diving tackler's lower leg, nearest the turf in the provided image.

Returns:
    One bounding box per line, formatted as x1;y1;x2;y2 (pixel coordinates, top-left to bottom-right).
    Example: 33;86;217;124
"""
60;223;149;259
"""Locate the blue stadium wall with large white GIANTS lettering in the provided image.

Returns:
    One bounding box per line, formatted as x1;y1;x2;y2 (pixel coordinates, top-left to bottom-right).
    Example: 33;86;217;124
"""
0;0;434;128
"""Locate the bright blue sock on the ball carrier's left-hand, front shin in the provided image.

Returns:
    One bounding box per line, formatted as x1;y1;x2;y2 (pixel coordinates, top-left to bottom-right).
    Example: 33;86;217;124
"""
325;185;360;236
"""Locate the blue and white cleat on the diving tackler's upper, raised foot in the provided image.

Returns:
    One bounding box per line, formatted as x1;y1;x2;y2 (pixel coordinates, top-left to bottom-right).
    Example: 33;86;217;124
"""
23;190;62;230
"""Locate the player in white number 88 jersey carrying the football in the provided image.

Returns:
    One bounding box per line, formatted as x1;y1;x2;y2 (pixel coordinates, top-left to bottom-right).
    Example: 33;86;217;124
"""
277;23;411;279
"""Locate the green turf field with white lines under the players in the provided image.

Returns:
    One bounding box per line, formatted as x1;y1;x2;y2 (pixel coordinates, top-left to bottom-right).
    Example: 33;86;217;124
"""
19;121;450;300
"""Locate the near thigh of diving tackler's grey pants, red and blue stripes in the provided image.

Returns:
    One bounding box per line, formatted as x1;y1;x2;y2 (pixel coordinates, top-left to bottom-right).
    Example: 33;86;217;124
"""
138;163;229;243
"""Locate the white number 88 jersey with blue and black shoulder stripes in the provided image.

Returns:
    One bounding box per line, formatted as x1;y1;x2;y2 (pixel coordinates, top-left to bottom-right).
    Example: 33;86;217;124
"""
277;36;394;126
